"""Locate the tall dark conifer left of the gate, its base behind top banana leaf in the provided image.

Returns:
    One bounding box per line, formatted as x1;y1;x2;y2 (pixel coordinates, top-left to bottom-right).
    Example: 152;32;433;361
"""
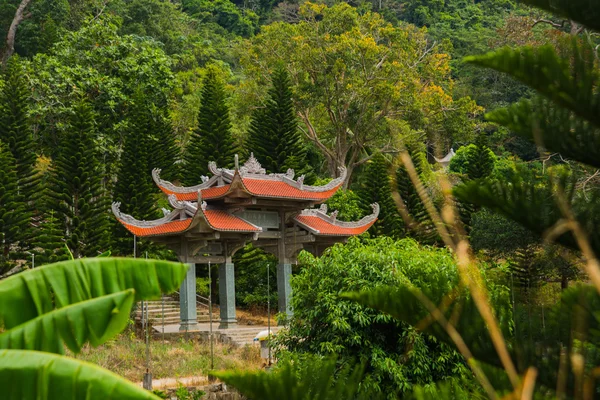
48;102;108;258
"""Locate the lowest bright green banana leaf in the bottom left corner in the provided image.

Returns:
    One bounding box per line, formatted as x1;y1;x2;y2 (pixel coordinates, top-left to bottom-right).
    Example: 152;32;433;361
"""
0;350;159;400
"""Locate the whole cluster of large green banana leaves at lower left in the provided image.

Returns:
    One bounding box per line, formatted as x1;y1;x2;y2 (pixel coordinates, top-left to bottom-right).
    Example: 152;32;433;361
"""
0;258;188;400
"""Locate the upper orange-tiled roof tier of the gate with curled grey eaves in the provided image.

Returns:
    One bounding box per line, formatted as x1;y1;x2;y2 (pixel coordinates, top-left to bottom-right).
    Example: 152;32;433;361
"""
152;154;346;203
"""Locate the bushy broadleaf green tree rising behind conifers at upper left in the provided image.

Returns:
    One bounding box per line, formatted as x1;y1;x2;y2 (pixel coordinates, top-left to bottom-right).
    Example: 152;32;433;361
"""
28;15;174;161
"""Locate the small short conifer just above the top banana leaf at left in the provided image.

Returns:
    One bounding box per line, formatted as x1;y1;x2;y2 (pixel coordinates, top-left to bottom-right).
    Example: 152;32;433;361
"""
33;211;69;266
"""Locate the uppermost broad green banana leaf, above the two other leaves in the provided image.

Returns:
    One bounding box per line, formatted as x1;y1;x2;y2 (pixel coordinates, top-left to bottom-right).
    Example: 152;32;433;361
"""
0;258;188;330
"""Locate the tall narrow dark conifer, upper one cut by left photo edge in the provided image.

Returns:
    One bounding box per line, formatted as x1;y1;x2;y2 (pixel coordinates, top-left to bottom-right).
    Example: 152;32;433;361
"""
0;56;38;203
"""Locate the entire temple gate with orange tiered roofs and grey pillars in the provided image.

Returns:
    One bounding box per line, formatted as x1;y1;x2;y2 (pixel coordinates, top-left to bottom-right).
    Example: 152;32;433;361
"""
112;155;379;330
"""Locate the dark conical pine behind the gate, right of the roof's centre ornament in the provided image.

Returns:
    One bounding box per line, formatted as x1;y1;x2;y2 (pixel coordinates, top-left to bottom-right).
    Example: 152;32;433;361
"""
246;66;308;174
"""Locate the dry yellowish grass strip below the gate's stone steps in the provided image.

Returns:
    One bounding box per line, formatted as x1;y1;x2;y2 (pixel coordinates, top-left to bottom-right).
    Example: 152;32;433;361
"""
69;333;262;382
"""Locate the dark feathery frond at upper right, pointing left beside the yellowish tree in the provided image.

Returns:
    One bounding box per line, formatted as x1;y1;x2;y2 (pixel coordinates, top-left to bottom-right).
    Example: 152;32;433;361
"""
465;40;600;130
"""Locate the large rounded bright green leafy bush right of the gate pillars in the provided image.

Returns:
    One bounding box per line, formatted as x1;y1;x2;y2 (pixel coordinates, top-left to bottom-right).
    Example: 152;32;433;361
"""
277;238;478;398
